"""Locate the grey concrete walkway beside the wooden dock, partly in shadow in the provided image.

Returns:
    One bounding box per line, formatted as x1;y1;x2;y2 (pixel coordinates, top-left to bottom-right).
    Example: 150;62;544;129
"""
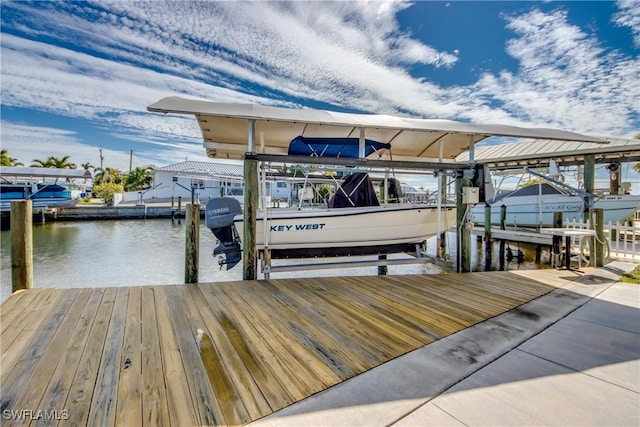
251;262;640;427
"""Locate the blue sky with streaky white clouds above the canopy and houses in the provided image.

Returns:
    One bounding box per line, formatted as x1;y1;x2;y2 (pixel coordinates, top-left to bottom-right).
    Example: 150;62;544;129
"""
0;0;640;191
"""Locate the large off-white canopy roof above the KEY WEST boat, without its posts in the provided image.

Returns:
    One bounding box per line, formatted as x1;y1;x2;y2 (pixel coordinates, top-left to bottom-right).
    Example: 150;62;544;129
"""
147;97;606;160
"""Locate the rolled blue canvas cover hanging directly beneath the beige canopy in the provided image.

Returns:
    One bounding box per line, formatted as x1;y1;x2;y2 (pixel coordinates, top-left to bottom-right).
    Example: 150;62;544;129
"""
289;136;391;159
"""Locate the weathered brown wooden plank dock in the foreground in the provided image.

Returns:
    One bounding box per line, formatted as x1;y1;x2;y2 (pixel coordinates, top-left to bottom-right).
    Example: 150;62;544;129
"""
0;270;577;426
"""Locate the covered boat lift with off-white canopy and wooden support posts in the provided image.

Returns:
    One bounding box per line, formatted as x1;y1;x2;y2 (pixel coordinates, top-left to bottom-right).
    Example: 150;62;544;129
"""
147;97;608;280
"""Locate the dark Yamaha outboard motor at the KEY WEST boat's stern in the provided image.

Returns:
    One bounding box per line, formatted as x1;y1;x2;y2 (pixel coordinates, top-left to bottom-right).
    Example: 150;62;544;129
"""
205;197;242;270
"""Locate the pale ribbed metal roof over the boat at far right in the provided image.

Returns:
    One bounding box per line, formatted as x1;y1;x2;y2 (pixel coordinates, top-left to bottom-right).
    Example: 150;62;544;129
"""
456;138;640;169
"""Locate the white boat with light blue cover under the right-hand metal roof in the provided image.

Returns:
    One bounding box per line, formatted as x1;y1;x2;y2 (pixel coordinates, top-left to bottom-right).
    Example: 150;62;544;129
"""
471;183;640;228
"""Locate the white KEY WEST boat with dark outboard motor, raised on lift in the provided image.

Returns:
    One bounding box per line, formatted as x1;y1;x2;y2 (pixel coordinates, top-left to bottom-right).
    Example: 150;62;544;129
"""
205;174;456;268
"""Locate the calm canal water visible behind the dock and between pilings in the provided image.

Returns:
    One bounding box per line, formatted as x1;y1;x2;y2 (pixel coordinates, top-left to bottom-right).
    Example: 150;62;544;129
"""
0;220;552;301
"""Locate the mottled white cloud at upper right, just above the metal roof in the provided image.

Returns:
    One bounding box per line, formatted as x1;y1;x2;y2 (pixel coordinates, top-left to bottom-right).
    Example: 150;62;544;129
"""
451;9;640;136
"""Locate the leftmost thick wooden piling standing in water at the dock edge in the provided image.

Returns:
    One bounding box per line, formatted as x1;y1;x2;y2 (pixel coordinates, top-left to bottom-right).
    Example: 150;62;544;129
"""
11;200;33;292
